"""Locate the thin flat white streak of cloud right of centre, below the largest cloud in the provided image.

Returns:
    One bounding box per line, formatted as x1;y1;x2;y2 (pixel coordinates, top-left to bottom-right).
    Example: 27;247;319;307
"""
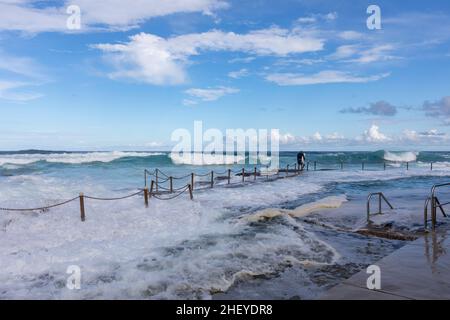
266;70;389;86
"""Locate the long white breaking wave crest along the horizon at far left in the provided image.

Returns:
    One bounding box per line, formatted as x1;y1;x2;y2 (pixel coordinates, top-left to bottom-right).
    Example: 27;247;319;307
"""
0;151;163;166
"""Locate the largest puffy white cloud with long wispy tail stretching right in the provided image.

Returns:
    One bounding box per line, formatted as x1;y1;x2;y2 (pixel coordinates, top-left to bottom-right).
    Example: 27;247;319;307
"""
94;27;323;85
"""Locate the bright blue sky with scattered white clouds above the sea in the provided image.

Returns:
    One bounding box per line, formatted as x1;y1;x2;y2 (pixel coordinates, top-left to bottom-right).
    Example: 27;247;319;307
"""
0;0;450;151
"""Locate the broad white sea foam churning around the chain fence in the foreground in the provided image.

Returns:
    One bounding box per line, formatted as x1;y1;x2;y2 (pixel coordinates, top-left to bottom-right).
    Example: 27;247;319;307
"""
0;159;448;299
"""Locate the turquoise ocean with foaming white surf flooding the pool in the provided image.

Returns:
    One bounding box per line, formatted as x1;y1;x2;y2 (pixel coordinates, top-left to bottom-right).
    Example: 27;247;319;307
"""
0;150;450;299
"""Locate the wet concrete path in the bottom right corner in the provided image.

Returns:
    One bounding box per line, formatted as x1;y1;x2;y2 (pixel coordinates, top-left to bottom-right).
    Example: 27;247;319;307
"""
319;229;450;300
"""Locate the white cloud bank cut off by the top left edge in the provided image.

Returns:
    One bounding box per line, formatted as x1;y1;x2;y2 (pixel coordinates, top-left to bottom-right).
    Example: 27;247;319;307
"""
0;0;228;33
